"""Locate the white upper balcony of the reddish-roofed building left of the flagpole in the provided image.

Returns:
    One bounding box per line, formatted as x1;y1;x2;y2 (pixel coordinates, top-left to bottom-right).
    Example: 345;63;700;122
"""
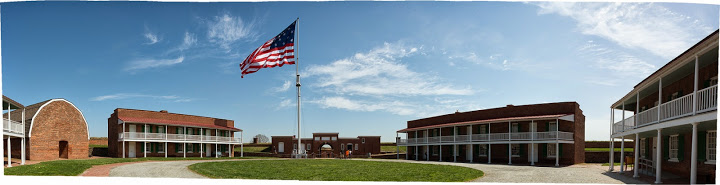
119;132;240;144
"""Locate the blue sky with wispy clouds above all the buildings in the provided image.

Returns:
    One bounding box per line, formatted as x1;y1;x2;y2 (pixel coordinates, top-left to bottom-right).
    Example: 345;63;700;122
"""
0;2;719;141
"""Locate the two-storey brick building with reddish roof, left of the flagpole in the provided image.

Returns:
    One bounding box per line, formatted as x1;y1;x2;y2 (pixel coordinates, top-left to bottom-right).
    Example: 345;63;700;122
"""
108;108;242;158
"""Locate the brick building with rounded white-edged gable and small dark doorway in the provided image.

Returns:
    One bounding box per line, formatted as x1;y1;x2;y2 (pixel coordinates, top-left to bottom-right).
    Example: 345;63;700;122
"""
3;97;90;161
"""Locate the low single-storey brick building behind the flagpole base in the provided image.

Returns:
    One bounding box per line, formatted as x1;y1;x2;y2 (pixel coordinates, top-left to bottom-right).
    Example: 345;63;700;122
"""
271;133;380;158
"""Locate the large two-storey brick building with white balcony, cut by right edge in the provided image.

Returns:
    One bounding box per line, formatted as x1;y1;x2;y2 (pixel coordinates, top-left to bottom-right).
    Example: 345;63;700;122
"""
609;31;719;184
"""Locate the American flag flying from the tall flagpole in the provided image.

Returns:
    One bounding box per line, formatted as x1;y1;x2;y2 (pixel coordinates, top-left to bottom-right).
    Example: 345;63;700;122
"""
240;20;297;78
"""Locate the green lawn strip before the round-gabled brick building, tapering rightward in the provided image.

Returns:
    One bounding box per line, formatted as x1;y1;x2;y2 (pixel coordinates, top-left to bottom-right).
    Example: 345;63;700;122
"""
5;157;270;176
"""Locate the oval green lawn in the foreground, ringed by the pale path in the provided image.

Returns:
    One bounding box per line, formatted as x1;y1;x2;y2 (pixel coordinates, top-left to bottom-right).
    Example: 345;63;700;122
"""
189;159;483;182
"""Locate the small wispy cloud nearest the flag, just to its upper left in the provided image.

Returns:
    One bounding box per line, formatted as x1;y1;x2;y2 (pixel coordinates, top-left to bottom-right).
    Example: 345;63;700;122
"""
208;13;256;51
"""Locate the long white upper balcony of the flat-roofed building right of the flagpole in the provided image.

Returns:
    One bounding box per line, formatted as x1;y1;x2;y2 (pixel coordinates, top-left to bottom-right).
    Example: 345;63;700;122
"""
398;131;573;145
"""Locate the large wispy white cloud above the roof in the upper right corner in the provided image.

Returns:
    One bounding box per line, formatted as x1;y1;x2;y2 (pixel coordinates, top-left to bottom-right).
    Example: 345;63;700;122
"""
537;2;714;59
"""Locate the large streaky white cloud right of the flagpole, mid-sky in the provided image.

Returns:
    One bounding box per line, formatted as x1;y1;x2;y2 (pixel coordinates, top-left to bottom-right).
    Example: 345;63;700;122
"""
305;43;473;96
